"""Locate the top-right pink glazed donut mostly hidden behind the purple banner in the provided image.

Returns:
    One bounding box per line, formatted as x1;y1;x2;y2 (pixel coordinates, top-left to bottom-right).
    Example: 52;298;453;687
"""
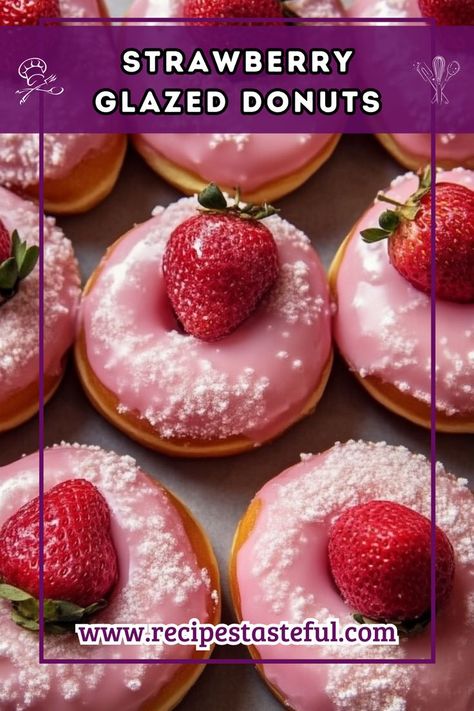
347;0;474;170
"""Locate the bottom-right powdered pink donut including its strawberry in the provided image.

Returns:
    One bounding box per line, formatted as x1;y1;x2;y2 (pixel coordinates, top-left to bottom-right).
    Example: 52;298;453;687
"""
230;441;474;711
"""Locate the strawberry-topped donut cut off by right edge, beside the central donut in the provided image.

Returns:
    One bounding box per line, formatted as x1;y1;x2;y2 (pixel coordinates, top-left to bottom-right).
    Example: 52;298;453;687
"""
329;168;474;432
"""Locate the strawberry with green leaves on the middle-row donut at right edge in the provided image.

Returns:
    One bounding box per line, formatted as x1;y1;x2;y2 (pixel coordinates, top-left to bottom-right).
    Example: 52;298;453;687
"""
361;171;474;303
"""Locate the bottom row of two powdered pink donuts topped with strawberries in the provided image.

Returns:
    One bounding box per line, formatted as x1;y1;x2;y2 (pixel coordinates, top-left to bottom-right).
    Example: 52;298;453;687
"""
0;441;474;711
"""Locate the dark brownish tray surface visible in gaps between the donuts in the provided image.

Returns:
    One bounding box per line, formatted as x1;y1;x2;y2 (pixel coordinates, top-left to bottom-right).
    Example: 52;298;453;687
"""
0;136;474;711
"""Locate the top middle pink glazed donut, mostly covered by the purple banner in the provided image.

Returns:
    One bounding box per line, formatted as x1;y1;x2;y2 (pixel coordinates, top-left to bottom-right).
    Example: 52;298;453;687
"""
124;0;342;202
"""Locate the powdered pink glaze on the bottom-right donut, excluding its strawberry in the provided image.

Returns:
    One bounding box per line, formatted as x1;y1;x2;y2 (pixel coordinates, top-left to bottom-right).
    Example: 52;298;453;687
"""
237;441;474;711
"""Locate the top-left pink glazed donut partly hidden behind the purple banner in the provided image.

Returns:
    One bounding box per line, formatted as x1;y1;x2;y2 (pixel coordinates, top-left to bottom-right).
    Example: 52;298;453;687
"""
0;0;127;214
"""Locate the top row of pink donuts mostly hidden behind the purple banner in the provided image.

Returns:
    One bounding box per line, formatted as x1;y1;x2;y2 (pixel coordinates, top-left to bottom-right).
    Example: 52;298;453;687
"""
0;0;474;214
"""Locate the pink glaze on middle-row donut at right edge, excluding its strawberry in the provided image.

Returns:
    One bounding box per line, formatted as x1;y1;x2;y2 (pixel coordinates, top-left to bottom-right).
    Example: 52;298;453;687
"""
334;168;474;414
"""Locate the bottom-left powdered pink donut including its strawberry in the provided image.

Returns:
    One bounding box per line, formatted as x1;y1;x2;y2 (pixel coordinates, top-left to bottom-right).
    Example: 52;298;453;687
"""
0;443;220;711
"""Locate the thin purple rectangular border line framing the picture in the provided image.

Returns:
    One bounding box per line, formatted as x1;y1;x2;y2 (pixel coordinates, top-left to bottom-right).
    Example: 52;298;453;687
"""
38;17;436;666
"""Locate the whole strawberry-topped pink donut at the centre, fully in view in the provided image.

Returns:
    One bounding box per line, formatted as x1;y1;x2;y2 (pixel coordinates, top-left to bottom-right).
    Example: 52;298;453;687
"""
76;185;332;456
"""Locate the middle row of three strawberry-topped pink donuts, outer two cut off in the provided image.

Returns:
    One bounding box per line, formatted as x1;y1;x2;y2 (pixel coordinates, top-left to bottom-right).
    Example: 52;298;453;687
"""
0;168;474;442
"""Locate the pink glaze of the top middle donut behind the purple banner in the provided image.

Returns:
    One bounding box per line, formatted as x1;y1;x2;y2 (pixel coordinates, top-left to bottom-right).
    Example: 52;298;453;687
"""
127;0;342;192
